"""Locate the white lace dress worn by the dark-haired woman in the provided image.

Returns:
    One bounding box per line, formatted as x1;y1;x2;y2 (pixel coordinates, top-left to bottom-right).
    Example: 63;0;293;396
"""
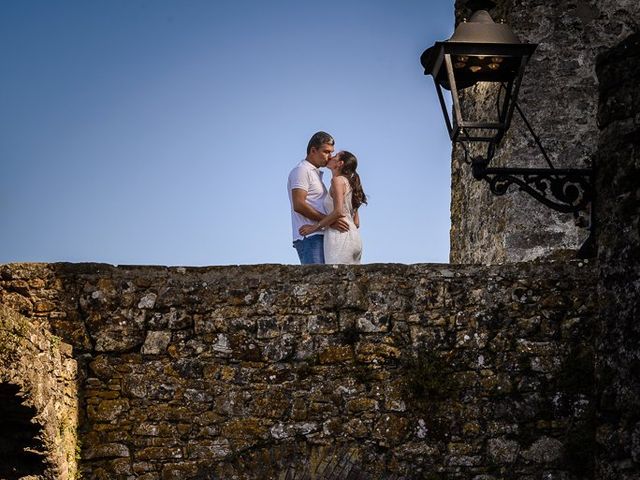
324;177;362;264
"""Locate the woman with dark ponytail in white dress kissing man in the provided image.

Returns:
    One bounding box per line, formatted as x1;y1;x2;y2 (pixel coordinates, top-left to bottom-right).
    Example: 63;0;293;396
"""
299;150;367;264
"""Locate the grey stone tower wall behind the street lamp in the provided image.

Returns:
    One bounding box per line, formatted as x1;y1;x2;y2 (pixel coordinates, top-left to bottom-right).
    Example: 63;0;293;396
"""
450;0;640;264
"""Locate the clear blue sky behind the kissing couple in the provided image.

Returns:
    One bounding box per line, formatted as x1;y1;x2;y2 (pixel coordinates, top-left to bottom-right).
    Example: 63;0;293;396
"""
0;0;453;265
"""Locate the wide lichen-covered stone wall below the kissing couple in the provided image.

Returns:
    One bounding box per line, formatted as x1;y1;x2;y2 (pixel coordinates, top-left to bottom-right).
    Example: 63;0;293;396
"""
0;262;596;480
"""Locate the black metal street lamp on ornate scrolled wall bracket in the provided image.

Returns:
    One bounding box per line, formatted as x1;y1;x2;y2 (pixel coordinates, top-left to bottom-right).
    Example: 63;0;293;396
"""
420;2;595;257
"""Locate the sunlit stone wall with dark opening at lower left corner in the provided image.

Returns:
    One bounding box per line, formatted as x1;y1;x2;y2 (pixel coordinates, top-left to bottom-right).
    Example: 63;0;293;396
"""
0;304;78;480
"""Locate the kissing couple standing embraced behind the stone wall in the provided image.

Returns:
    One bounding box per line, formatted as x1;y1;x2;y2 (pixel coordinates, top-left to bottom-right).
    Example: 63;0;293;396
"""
287;132;367;265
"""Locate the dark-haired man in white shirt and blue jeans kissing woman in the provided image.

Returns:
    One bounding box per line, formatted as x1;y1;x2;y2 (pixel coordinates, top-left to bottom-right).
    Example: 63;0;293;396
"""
287;132;349;265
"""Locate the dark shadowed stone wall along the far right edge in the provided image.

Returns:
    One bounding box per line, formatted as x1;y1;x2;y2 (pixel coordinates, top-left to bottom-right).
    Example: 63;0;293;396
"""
597;33;640;479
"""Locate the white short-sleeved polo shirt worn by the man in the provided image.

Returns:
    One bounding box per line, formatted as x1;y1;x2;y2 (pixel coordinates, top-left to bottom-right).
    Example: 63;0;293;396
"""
287;159;327;242
